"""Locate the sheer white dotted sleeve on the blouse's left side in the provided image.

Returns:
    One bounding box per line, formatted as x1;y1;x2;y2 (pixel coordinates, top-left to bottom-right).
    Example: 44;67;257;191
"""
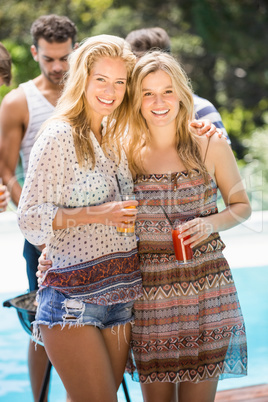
18;127;64;245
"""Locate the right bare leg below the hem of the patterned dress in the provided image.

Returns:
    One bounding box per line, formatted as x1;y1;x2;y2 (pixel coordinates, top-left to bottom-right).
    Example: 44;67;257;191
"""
179;380;218;402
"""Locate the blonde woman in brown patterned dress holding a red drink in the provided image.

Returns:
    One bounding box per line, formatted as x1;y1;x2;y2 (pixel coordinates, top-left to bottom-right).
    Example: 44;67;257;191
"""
128;52;251;402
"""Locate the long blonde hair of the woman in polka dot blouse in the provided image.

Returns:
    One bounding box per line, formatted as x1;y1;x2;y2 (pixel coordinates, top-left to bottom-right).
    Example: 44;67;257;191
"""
44;35;136;166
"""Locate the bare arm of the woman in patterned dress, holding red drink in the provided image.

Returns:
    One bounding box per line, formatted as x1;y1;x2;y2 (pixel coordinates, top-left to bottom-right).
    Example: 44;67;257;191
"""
181;136;251;247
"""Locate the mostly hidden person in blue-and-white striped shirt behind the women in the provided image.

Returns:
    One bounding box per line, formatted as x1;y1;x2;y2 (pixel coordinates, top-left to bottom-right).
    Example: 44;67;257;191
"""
125;27;231;144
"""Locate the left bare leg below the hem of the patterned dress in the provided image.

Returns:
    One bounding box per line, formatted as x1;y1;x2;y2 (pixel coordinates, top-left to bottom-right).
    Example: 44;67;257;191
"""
141;382;176;402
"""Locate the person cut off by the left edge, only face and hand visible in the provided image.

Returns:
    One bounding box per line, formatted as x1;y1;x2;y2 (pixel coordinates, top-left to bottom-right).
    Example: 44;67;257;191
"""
0;42;11;212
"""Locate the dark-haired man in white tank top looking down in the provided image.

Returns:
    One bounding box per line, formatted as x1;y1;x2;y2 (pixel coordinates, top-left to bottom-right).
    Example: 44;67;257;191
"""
0;14;77;400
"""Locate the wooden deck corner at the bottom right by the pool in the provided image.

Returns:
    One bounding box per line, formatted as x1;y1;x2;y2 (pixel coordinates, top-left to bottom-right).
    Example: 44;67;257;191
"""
215;384;268;402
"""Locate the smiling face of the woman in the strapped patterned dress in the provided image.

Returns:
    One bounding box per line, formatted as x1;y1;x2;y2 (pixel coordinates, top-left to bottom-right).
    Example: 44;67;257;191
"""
141;70;180;131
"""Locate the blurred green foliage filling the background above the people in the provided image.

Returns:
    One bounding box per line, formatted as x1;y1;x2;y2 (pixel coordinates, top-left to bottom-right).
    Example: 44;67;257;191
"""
0;0;268;206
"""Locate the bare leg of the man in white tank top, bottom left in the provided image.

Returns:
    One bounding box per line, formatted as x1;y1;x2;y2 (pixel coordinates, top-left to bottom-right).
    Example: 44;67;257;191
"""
28;340;48;402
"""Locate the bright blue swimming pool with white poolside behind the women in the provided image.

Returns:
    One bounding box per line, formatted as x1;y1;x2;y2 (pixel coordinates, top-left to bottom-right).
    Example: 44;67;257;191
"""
0;213;268;402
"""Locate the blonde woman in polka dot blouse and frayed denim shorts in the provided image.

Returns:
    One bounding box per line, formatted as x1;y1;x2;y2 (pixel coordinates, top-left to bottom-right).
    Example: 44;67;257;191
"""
18;35;141;402
